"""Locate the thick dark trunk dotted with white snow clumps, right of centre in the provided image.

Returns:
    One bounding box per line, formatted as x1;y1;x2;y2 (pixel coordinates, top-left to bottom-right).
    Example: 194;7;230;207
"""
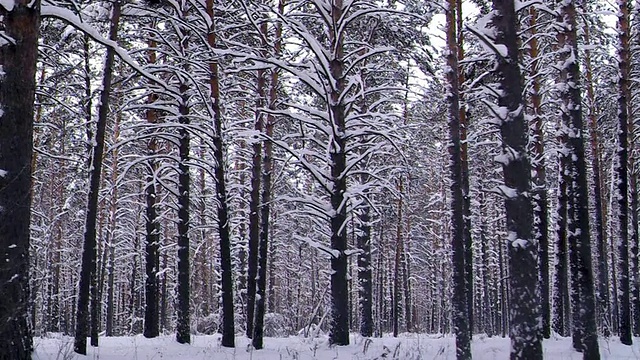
492;0;542;359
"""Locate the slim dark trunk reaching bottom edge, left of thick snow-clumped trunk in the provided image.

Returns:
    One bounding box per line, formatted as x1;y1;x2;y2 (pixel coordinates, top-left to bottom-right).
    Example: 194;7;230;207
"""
446;0;471;354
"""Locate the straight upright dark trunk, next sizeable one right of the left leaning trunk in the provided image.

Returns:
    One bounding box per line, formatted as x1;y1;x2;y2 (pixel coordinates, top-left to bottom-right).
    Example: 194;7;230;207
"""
144;40;160;338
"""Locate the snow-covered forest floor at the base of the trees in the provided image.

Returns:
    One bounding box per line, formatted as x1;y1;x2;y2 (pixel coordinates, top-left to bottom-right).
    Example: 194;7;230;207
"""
33;334;640;360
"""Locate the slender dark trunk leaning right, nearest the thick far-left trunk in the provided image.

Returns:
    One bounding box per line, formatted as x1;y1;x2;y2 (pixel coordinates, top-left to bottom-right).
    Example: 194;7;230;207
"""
73;2;120;355
